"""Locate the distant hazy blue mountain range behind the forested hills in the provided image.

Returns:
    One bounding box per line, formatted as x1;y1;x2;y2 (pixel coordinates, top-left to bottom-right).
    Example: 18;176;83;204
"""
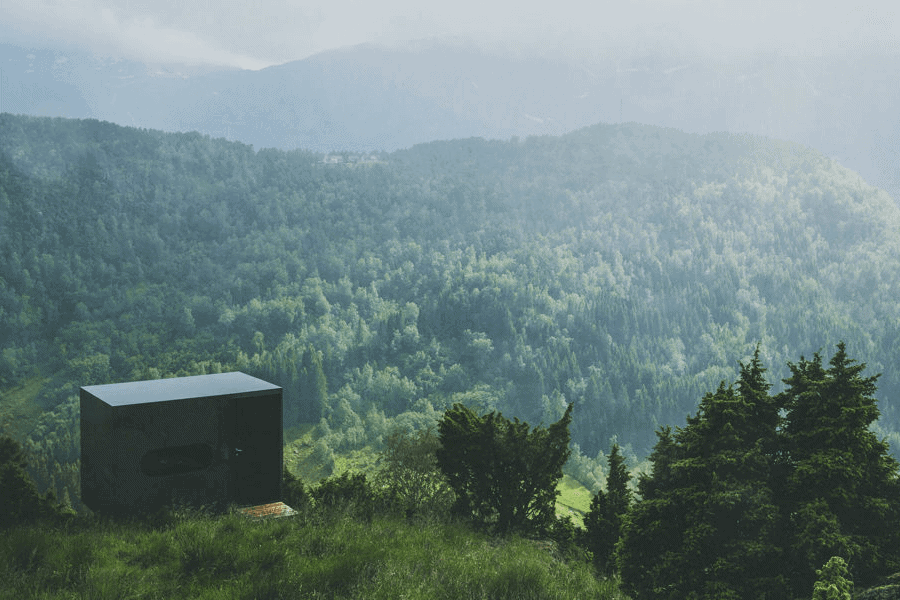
0;41;900;203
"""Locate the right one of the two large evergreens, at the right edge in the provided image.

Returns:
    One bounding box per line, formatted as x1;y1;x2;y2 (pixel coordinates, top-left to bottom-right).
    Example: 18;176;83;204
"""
783;342;900;591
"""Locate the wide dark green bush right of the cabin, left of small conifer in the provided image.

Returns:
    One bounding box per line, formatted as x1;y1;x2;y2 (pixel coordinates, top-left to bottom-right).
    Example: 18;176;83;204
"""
437;404;573;533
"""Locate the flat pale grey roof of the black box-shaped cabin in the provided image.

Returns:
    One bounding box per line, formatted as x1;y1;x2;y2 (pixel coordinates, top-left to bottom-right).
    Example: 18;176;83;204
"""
81;371;281;406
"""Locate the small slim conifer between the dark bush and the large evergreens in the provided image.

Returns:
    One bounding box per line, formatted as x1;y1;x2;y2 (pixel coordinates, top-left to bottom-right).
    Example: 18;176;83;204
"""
584;444;631;574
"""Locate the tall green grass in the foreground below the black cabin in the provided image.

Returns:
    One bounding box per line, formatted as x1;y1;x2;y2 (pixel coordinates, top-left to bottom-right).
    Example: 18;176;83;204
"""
0;514;624;600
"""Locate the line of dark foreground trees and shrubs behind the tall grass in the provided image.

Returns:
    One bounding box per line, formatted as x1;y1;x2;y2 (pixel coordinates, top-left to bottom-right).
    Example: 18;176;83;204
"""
0;342;900;600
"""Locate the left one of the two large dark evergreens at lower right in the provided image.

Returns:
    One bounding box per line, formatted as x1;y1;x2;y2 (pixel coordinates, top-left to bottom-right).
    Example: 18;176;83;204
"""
619;378;784;600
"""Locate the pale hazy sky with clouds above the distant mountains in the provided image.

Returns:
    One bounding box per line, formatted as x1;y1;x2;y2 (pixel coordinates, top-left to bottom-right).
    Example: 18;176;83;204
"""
0;0;900;69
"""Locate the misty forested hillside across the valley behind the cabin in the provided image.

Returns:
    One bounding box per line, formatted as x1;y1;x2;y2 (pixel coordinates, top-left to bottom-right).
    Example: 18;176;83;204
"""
0;114;900;505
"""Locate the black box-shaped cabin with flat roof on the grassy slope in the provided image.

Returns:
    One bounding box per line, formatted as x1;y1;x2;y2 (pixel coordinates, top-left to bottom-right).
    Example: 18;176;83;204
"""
81;372;283;514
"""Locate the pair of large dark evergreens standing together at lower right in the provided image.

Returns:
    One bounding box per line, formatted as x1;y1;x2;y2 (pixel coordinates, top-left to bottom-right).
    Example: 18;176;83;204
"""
618;344;900;598
